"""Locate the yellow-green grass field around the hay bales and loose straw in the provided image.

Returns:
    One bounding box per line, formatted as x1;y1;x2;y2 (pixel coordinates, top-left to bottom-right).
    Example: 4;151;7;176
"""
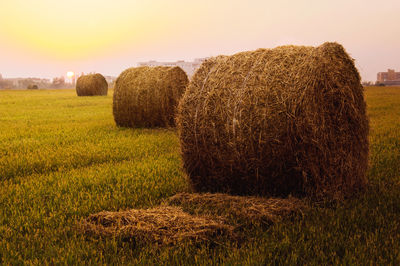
0;87;400;265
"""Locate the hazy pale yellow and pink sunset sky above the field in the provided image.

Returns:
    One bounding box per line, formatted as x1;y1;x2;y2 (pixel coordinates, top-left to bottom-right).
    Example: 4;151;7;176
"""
0;0;400;81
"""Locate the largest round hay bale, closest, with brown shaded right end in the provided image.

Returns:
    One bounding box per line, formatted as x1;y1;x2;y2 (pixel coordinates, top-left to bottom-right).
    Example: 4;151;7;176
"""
177;43;369;199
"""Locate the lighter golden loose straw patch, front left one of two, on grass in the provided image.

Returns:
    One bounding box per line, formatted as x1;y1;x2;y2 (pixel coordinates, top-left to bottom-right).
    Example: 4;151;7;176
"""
81;206;234;245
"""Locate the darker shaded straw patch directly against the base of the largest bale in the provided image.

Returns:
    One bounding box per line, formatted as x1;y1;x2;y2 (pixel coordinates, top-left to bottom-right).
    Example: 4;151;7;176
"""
165;193;306;225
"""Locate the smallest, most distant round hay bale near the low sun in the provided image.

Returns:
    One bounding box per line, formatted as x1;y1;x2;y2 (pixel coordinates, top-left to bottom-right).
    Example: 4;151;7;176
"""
76;74;108;96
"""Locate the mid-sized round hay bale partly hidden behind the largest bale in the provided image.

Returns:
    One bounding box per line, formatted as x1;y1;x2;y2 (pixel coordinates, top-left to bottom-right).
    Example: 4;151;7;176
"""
113;67;189;127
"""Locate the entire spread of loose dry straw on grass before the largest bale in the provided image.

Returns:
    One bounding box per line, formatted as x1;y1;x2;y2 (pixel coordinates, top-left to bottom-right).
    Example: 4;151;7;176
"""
80;193;306;245
